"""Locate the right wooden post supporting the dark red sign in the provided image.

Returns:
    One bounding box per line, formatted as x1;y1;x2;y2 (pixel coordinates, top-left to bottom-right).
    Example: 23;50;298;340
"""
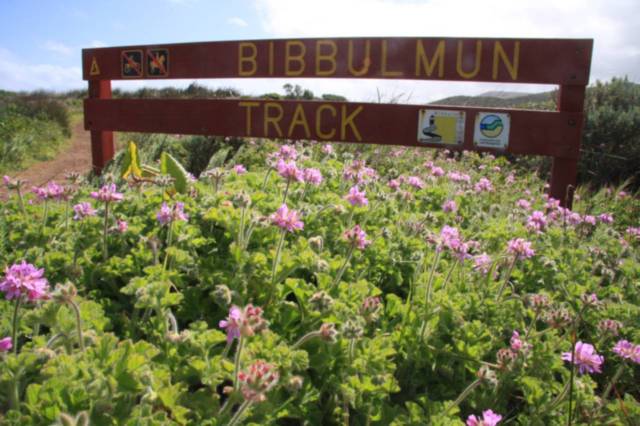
549;86;586;209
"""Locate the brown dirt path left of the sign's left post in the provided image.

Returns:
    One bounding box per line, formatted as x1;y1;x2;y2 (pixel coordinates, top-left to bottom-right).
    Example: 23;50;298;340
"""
0;120;91;197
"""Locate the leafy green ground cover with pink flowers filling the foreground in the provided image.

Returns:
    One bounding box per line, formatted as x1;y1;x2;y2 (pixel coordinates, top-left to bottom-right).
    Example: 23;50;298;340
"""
0;141;640;426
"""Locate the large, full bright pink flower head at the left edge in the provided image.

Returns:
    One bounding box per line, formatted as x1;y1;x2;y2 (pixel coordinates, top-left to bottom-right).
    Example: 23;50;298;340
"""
0;260;49;302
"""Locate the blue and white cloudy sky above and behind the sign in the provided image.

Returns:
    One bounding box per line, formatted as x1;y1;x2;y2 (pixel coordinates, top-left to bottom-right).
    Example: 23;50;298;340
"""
0;0;640;103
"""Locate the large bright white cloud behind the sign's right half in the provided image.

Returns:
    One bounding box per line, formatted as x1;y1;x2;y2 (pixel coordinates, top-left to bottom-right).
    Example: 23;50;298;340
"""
254;0;640;102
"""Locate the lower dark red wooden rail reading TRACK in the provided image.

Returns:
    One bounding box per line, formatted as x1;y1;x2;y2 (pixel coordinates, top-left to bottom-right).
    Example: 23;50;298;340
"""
85;99;583;158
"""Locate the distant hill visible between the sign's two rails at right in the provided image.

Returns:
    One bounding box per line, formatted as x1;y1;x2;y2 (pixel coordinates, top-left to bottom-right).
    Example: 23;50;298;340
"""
431;91;555;109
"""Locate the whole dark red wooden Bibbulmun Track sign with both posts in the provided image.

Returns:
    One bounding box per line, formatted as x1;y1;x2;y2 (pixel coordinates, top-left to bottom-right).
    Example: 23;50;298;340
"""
82;37;593;204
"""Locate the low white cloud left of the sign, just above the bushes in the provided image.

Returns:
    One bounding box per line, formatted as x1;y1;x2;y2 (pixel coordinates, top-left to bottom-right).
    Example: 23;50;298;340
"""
0;47;85;90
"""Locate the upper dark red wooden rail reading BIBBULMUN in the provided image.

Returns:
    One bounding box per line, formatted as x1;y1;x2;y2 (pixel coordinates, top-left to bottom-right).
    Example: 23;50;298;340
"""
82;37;593;85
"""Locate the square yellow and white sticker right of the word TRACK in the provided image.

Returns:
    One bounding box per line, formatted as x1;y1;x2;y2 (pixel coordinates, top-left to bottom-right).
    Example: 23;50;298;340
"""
418;109;464;145
